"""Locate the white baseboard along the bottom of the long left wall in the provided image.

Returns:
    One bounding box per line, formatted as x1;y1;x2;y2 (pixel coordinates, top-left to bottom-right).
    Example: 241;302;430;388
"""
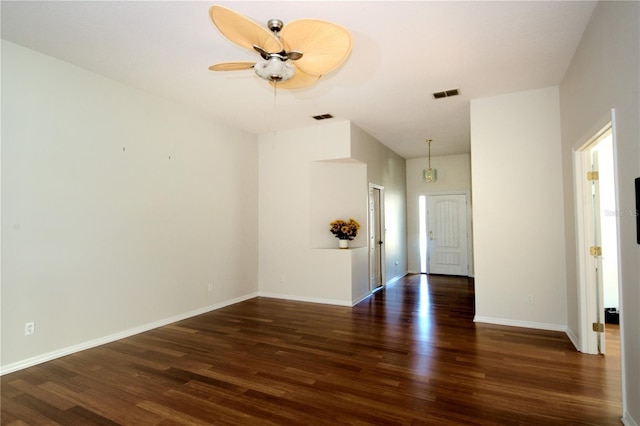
0;293;258;376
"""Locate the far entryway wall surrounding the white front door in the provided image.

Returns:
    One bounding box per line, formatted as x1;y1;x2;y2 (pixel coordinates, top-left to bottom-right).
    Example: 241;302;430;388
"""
407;154;473;275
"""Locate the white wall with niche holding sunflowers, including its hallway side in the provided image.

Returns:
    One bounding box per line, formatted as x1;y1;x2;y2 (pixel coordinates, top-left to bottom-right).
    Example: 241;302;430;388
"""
259;121;406;306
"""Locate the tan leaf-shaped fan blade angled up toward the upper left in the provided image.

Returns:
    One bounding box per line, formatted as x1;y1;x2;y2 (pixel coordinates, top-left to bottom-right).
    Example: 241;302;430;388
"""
209;6;282;53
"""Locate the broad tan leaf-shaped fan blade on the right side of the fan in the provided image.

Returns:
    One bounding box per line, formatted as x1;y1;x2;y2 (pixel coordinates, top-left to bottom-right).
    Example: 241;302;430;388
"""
280;19;352;76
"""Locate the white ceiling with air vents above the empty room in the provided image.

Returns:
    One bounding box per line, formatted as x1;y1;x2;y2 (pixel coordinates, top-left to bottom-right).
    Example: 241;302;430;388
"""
1;0;595;159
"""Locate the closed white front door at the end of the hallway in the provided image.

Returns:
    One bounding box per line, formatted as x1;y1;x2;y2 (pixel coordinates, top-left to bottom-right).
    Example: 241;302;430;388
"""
427;195;469;276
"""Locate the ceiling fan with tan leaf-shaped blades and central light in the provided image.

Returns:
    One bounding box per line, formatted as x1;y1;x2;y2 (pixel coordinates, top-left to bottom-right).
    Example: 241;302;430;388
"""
209;5;352;89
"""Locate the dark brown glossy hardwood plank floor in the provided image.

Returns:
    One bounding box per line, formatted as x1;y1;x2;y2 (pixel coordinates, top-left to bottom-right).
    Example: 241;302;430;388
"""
1;275;622;426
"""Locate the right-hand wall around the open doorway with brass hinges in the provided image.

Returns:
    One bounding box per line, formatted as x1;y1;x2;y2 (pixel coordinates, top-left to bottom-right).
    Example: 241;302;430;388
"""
560;2;640;425
